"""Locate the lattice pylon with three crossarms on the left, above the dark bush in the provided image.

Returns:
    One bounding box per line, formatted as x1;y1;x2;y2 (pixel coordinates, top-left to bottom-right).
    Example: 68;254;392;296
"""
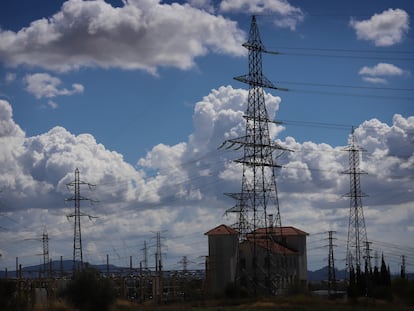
65;168;96;272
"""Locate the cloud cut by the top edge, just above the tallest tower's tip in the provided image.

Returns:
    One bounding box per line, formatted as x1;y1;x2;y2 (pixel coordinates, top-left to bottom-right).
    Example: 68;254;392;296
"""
220;0;304;30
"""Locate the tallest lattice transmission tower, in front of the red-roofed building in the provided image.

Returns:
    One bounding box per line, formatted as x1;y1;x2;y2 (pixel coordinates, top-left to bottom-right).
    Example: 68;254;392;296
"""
222;16;287;289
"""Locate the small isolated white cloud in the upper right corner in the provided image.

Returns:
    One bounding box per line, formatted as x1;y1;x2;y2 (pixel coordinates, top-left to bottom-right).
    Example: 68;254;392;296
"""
349;9;410;46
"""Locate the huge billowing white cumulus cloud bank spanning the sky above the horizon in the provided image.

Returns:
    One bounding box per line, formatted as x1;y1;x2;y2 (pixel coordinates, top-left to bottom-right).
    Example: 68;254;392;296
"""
0;86;414;270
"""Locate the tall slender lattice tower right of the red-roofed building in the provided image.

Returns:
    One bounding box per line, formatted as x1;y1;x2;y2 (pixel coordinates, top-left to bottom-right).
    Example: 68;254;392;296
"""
344;129;371;276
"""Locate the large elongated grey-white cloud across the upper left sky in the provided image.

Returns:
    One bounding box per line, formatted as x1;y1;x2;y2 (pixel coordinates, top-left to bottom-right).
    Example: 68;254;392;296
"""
0;0;245;73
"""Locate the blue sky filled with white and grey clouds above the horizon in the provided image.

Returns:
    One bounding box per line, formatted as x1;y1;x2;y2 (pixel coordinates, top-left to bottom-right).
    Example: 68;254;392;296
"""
0;0;414;273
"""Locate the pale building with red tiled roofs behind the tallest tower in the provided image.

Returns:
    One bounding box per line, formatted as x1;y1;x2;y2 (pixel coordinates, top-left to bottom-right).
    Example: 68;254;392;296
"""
205;225;308;295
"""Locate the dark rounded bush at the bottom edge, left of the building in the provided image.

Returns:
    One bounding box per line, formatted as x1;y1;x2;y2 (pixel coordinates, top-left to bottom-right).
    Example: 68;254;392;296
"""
63;268;116;311
